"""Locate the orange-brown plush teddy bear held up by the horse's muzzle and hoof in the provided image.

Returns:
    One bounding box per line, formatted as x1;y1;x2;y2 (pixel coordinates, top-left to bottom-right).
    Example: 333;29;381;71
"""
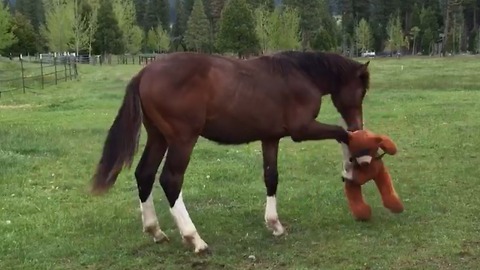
343;130;403;221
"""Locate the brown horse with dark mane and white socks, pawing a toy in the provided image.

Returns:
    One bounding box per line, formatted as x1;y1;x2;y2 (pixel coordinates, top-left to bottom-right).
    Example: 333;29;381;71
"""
92;52;369;252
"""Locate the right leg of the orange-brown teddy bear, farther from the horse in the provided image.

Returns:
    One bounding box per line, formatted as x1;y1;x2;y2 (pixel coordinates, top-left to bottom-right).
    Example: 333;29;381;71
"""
373;167;403;213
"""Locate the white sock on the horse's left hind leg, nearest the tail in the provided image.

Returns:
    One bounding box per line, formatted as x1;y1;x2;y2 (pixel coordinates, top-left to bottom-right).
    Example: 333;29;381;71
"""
140;194;168;243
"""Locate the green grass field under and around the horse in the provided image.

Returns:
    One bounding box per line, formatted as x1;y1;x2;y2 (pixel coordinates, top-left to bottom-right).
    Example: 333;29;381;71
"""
0;57;480;269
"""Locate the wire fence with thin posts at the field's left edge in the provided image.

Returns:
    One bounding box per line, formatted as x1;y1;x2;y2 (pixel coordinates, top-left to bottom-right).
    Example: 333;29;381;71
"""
0;56;78;97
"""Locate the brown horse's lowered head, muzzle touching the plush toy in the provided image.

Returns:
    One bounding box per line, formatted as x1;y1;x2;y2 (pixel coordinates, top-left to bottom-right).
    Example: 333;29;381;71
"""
331;61;370;131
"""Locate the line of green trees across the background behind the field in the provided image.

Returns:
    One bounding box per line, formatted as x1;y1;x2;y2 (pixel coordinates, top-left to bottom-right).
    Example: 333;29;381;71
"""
0;0;480;57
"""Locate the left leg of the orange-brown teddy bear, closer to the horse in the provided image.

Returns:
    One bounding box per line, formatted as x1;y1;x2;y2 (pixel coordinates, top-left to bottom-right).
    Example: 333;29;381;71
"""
344;181;372;221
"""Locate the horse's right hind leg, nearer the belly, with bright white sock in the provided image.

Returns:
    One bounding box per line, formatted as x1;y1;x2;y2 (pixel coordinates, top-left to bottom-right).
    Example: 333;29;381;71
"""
160;138;208;253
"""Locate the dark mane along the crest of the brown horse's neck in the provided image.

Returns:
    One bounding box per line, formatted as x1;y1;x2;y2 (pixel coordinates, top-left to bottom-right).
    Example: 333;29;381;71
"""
264;51;370;89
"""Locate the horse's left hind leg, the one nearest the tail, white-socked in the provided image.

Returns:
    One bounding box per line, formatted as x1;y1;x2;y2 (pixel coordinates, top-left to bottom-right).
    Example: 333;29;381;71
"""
135;123;168;243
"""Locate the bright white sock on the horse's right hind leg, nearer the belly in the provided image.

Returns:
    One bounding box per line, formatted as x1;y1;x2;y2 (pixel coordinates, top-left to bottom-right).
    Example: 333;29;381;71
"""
170;192;208;253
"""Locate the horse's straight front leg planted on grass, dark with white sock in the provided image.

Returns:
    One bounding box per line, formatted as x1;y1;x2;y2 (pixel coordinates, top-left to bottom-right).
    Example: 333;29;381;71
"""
262;140;285;236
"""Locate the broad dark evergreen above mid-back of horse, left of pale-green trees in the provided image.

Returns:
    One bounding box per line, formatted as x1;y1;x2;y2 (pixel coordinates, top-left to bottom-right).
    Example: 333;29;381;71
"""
217;0;259;57
